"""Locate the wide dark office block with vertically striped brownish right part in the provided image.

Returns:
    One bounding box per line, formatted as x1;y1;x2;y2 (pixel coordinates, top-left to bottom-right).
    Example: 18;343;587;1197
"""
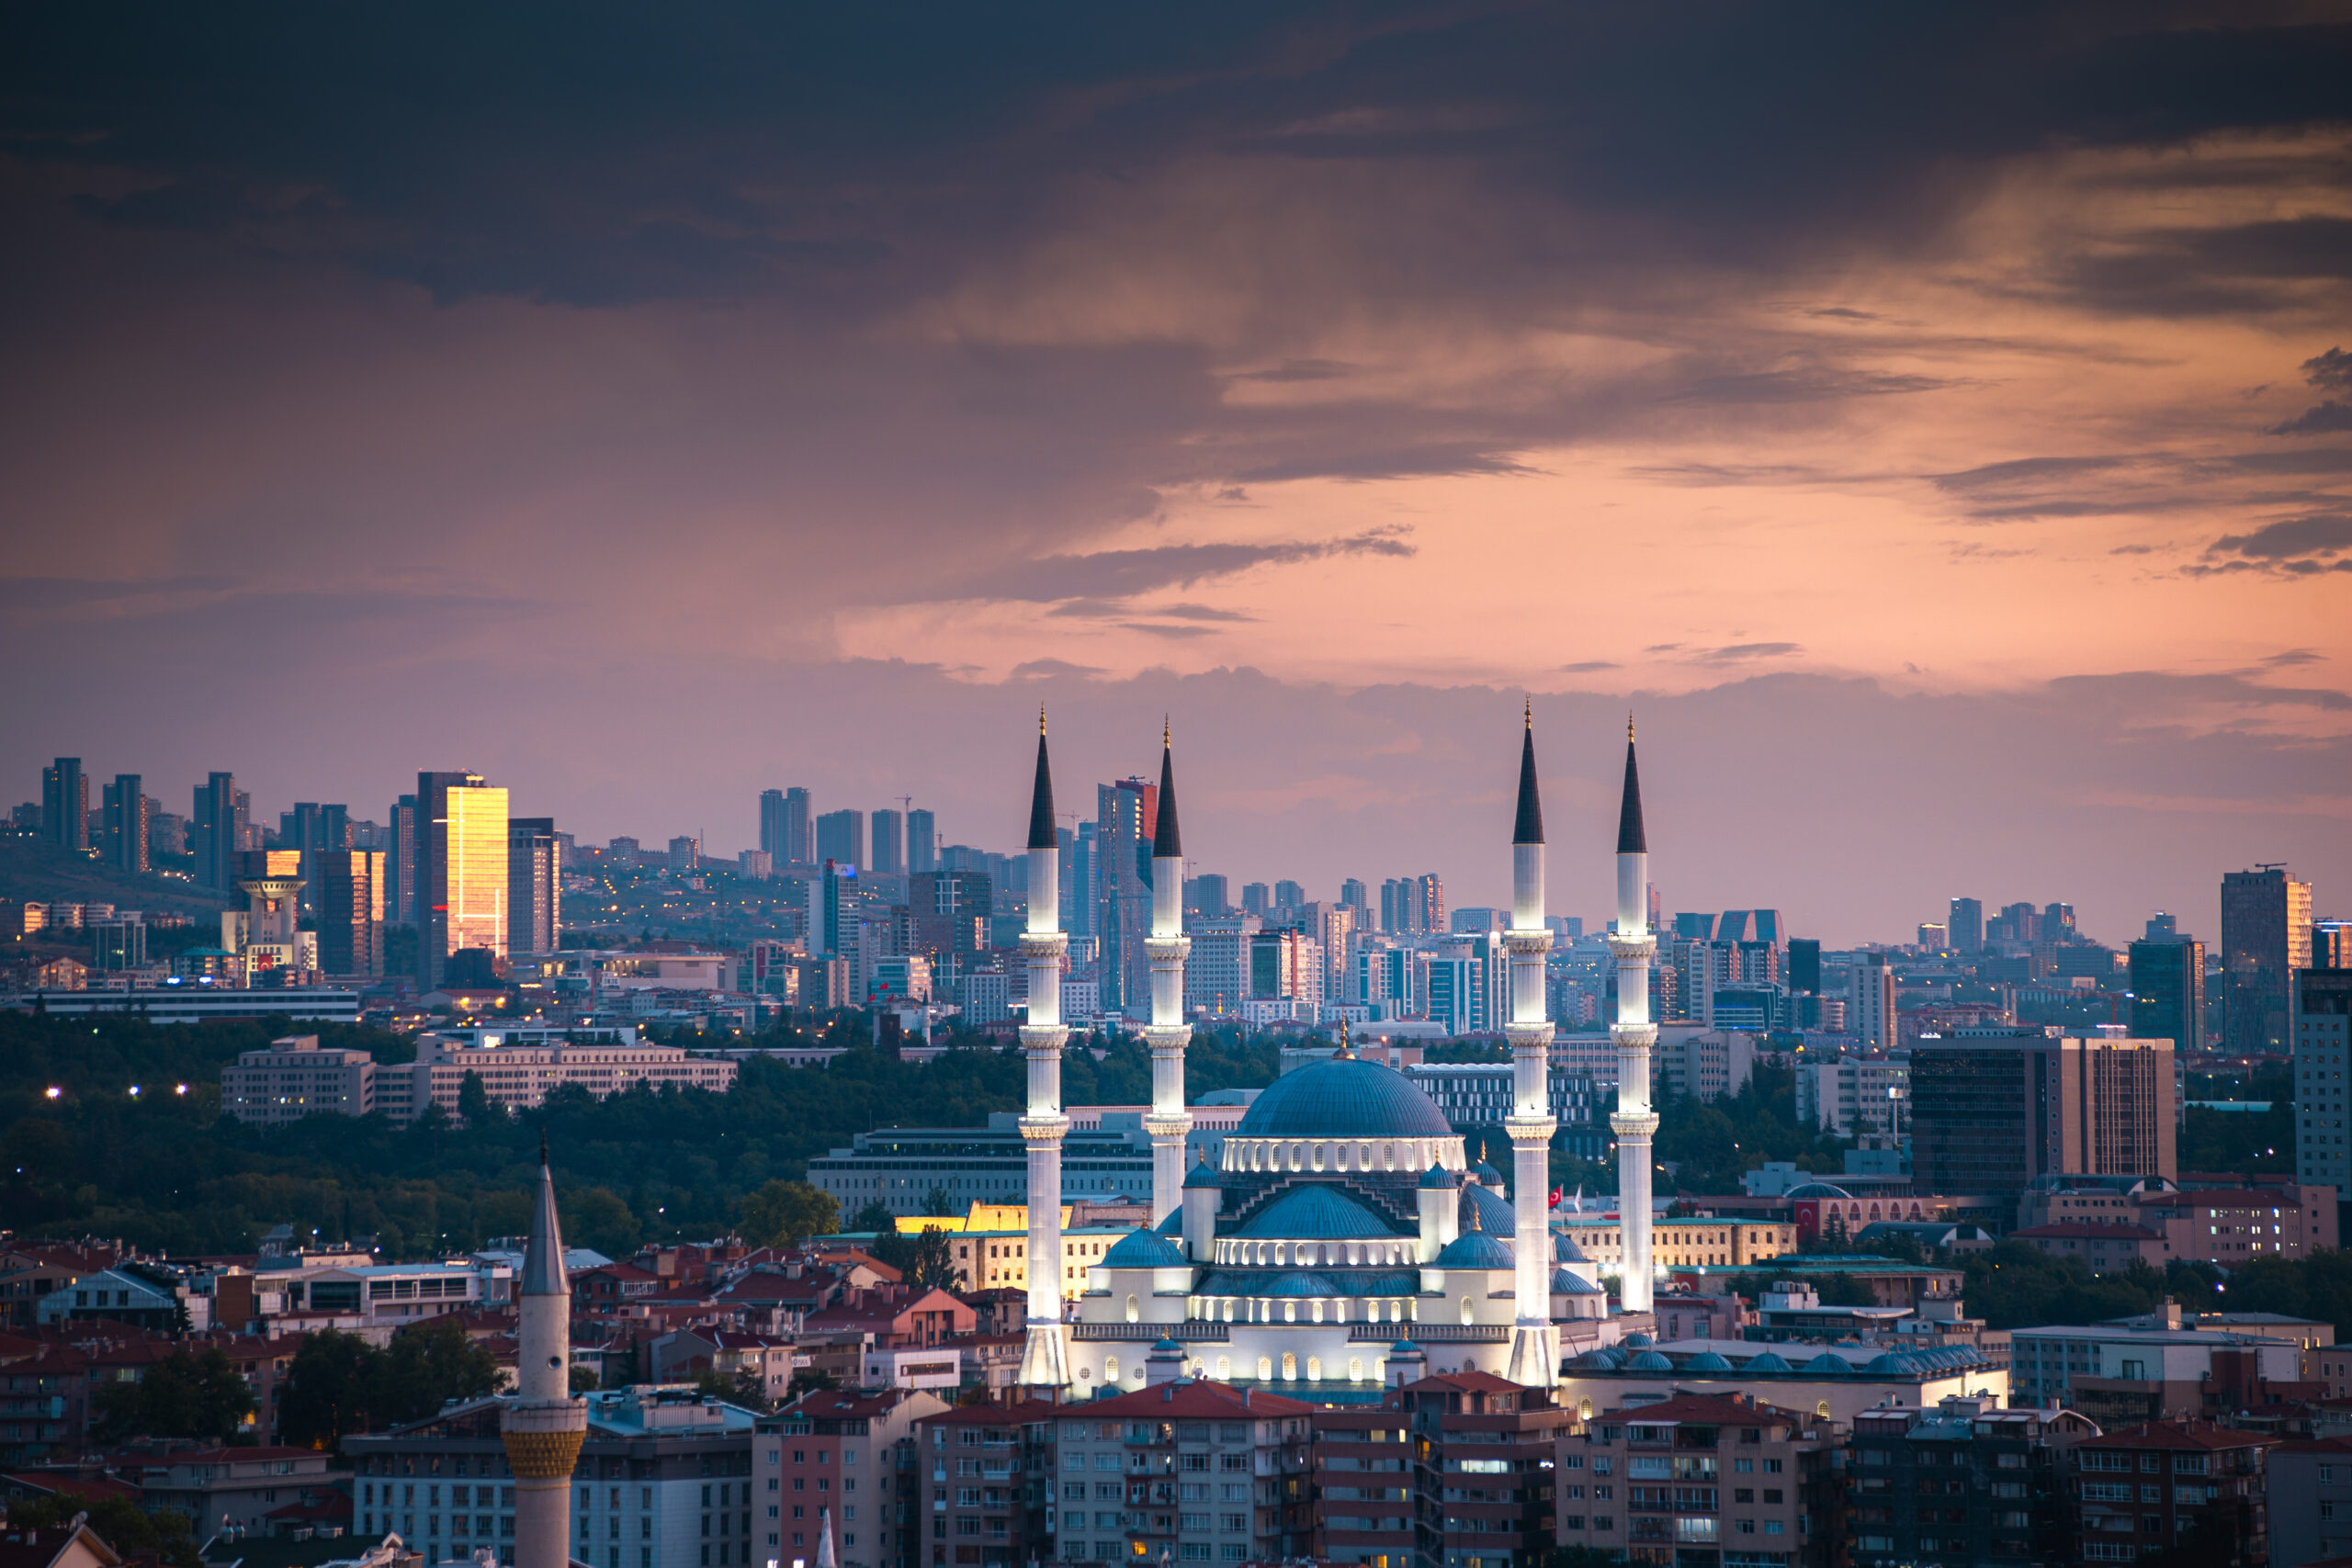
1912;1025;2180;1194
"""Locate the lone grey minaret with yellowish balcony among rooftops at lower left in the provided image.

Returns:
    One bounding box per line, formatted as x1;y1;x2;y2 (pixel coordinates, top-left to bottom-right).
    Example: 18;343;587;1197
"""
499;1138;588;1568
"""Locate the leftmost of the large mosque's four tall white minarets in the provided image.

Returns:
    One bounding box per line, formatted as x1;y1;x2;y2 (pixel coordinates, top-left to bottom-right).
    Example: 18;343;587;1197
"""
1021;707;1070;1389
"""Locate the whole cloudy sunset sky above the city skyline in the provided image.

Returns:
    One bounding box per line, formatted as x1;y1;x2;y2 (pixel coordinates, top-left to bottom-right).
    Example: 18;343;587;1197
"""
0;3;2352;942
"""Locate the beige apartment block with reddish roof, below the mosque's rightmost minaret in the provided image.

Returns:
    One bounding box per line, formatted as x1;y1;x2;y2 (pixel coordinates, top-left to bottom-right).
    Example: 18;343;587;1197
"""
1555;1394;1844;1568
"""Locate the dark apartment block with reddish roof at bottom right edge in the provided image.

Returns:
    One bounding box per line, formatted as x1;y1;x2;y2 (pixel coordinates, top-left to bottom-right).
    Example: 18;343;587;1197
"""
2070;1420;2279;1568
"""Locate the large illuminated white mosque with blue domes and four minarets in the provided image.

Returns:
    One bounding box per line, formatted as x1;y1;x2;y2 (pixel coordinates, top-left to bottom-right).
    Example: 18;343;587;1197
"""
1021;715;1658;1404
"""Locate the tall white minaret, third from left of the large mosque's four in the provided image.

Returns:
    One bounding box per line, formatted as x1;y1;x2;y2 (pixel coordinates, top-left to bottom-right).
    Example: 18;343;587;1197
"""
1503;701;1559;1389
